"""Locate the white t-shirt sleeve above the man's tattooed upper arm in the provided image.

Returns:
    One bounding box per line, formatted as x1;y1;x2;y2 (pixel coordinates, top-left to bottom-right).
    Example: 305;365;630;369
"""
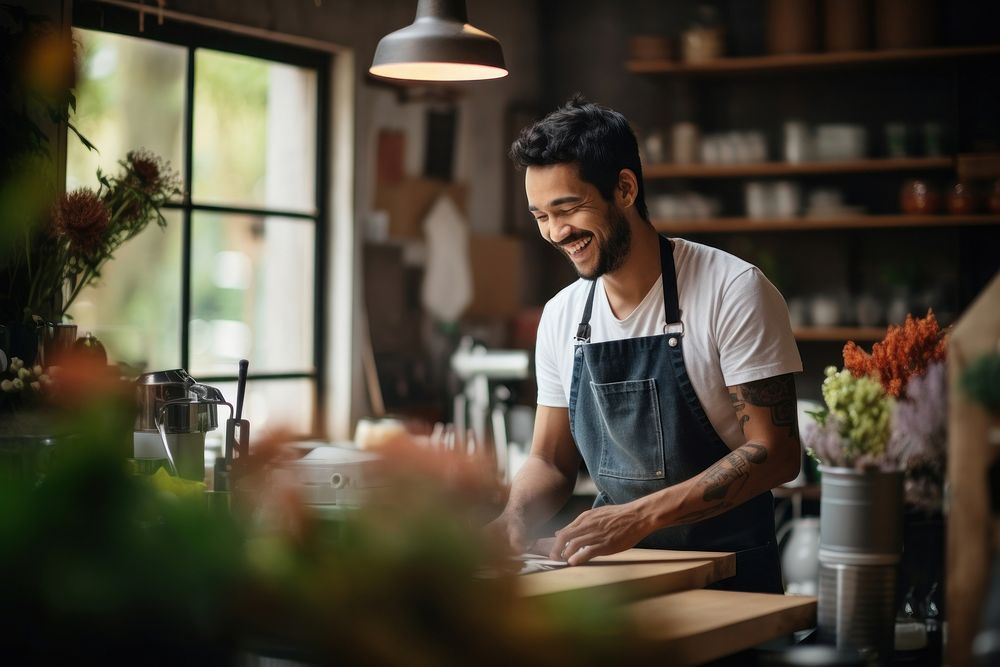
717;268;802;387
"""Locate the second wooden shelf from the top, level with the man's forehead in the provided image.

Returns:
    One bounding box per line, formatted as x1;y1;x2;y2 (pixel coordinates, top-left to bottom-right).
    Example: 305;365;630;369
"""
642;157;955;179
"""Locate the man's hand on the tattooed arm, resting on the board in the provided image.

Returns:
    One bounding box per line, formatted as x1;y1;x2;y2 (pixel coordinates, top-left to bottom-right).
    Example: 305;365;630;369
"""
549;500;653;565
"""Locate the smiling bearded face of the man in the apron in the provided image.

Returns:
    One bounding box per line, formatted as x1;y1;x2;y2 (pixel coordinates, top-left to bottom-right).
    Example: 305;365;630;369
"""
524;164;632;280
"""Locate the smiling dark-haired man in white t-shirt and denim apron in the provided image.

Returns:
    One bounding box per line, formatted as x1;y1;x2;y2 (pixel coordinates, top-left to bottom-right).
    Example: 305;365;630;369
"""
490;97;802;593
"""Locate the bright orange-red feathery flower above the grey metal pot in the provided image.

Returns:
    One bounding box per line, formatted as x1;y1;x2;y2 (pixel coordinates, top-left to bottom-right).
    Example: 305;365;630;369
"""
844;309;948;398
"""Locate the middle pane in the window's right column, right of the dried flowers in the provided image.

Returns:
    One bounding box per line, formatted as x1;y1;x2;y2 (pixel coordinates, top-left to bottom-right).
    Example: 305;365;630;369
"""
190;211;316;377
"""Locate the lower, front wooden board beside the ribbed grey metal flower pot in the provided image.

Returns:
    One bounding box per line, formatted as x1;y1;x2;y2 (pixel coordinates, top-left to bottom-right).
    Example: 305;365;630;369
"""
625;590;816;665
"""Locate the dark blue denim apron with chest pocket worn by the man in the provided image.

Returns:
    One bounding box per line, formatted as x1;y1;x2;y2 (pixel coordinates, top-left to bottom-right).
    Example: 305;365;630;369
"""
569;236;782;593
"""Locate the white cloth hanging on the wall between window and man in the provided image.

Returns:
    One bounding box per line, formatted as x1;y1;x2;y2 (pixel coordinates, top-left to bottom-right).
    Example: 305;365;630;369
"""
420;195;472;322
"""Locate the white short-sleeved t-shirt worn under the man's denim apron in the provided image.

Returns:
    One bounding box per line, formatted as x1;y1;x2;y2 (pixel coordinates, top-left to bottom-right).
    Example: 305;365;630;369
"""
535;239;802;449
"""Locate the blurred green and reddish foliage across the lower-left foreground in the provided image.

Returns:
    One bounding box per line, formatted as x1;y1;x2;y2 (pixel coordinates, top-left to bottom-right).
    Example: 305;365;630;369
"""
0;358;640;665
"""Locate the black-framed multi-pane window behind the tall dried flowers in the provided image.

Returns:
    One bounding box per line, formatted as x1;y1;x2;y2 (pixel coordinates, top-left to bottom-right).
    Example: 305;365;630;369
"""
66;10;331;434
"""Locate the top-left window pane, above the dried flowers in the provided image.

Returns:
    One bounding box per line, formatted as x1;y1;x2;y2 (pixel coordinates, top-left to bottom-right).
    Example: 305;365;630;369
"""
66;30;187;190
